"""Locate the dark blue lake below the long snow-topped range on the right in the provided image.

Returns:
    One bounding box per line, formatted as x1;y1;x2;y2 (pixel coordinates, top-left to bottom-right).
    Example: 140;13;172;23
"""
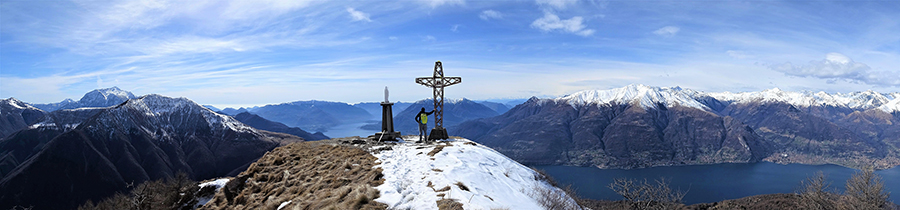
534;162;900;205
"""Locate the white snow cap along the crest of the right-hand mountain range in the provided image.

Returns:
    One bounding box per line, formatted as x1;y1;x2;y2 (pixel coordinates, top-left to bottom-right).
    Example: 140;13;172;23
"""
552;85;900;113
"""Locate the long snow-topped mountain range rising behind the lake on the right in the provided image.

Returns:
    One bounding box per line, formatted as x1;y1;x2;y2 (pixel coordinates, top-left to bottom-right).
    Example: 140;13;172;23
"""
450;85;900;168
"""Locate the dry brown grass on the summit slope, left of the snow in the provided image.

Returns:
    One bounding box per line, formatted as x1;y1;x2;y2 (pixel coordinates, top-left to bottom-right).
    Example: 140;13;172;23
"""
200;142;387;209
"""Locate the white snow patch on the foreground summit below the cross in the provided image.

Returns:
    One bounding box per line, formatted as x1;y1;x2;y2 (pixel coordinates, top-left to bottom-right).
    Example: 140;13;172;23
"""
373;139;575;209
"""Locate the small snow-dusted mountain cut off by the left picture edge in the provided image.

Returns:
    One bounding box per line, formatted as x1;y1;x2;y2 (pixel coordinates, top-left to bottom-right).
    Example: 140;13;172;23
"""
0;98;46;139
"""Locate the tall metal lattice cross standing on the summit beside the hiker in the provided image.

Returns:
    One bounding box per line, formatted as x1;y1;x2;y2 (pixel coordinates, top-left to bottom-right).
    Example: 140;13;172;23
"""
416;61;462;140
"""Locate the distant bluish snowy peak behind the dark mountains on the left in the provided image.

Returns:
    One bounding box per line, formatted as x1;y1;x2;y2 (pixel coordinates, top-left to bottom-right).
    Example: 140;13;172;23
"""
33;87;136;112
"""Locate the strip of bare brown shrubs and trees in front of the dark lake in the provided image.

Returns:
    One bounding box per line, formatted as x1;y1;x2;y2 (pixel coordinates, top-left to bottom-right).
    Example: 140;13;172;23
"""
579;170;900;210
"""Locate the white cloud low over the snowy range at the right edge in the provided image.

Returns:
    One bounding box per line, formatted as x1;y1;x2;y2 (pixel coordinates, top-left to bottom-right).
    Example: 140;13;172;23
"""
769;53;900;86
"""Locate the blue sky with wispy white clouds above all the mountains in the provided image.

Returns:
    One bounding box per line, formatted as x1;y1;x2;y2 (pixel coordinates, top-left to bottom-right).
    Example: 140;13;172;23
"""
0;0;900;107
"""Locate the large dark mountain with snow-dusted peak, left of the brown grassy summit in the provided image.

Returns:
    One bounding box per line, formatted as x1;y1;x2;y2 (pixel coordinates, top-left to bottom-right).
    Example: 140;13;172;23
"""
0;94;302;209
